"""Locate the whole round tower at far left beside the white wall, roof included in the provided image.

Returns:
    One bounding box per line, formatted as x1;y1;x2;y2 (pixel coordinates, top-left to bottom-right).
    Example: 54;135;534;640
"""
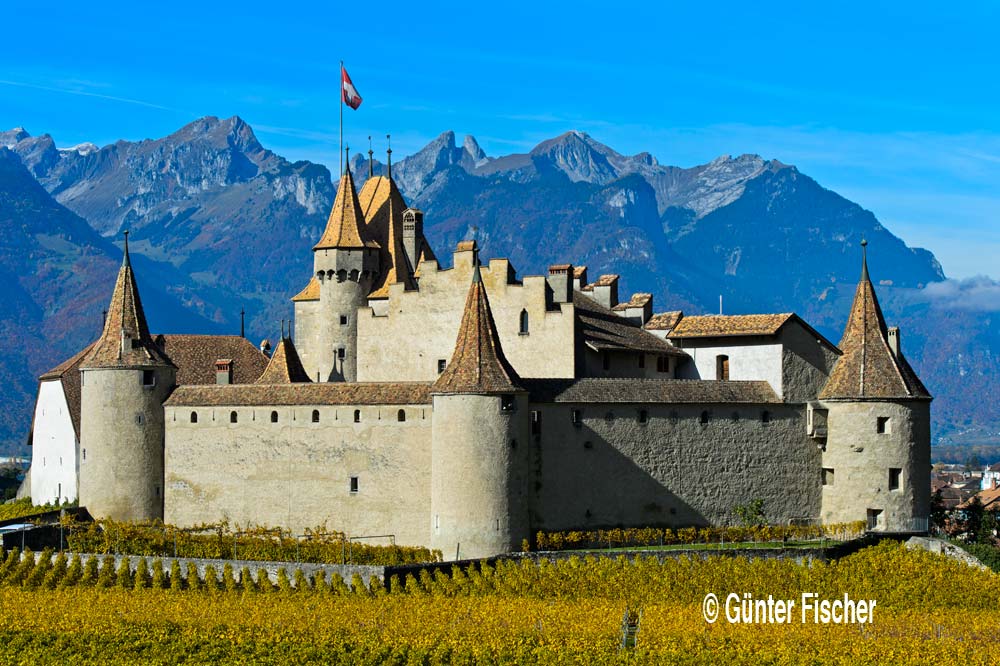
80;233;177;520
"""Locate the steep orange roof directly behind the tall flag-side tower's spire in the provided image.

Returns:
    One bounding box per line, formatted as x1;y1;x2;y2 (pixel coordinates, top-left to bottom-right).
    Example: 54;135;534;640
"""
358;176;416;298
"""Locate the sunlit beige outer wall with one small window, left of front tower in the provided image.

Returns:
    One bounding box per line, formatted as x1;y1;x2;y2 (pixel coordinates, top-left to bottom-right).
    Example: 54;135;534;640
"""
164;405;432;545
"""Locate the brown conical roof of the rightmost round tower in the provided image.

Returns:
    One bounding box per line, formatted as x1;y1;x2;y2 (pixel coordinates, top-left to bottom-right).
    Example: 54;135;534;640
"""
819;243;931;400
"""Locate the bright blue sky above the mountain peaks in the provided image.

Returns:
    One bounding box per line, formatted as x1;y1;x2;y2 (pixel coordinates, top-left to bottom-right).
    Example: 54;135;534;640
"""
0;0;1000;278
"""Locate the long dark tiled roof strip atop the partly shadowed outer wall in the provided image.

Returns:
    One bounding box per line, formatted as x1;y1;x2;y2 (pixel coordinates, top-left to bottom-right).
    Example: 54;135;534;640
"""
522;378;781;404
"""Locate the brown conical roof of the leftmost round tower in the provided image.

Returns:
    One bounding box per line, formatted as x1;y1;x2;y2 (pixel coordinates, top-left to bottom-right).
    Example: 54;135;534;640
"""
80;233;173;368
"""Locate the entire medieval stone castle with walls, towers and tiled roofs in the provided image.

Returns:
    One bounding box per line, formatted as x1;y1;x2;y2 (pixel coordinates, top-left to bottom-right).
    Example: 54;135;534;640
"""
23;149;931;559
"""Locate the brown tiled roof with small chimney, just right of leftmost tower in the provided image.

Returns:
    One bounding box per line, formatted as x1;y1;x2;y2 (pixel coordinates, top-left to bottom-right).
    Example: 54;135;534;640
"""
156;334;268;386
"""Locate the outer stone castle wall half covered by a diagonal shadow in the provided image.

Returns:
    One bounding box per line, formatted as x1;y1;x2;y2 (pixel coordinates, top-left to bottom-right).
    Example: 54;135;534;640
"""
531;403;822;530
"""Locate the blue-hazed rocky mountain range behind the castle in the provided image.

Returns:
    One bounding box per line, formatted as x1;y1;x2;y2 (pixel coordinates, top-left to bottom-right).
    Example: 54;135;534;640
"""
0;117;1000;450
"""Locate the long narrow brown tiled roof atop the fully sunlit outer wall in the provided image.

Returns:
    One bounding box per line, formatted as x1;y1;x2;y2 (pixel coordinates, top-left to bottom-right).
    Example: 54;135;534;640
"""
165;382;431;407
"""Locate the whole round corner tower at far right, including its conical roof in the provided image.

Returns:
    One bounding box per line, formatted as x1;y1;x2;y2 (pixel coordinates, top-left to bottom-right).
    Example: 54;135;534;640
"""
812;241;931;532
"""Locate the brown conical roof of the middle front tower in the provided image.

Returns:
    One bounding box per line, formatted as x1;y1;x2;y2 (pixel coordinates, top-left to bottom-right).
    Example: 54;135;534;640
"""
431;264;522;394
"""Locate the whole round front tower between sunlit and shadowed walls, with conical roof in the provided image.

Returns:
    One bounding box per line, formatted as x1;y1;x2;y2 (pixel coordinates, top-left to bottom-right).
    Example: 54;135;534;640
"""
431;259;530;559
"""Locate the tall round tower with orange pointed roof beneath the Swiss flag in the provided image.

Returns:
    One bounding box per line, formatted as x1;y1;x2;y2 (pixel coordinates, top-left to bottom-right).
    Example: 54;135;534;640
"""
293;148;379;382
